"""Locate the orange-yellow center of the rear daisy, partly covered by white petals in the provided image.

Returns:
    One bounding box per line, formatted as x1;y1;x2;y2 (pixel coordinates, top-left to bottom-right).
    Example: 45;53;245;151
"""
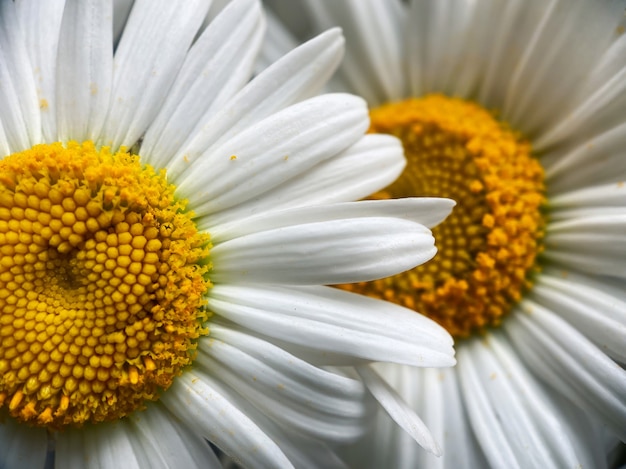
343;95;545;338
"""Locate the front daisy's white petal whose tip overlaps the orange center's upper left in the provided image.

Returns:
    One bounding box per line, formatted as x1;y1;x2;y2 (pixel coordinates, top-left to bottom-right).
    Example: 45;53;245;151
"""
197;134;404;228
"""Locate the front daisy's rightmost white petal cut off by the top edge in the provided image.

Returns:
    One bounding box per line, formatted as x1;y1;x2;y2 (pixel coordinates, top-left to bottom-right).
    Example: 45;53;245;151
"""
141;0;264;167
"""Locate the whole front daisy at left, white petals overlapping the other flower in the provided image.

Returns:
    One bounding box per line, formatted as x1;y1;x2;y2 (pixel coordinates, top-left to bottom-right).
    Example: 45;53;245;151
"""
0;0;454;469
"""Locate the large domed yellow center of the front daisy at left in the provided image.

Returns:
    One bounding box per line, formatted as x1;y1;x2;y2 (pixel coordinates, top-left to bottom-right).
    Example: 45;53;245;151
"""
0;142;210;428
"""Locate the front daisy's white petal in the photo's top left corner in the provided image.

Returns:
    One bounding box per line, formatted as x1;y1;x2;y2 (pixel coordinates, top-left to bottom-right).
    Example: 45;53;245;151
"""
0;1;41;152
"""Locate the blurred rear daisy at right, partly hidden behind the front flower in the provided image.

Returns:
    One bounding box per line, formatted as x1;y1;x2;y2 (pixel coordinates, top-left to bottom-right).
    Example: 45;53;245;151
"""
264;0;626;467
